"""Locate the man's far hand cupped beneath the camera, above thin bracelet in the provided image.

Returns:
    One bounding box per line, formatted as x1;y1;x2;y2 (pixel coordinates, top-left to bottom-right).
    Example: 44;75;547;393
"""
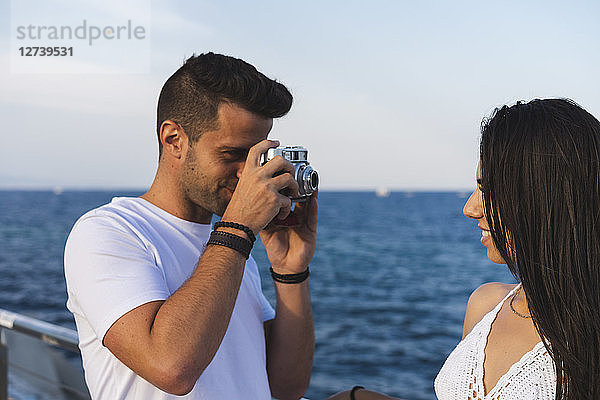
260;192;319;274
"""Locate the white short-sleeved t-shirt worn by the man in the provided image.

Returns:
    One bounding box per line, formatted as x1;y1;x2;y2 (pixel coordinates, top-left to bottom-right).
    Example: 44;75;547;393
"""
65;198;275;400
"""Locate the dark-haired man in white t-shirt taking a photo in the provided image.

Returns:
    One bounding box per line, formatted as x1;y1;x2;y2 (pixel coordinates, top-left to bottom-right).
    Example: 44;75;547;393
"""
65;53;318;400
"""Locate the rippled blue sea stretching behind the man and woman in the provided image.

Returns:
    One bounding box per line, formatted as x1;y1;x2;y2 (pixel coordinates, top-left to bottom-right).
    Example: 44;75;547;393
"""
0;190;514;400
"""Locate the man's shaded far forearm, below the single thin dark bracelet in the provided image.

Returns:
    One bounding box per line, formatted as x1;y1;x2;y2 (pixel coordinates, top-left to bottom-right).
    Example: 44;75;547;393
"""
267;280;315;400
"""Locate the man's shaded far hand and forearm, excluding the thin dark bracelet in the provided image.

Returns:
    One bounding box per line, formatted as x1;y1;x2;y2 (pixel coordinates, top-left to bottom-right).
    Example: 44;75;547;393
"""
260;192;318;399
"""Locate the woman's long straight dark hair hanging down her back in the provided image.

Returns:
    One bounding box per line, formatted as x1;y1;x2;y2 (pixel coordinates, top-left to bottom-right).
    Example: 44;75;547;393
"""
480;99;600;400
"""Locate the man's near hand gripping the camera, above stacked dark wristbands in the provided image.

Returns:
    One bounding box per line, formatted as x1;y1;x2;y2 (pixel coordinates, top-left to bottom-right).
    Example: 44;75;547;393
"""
222;140;298;234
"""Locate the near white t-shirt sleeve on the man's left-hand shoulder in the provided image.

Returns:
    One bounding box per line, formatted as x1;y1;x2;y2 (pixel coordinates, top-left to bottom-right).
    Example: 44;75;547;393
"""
65;215;170;341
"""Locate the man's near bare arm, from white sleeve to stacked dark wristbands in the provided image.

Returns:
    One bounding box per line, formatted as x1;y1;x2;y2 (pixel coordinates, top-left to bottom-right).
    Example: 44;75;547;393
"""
105;246;246;394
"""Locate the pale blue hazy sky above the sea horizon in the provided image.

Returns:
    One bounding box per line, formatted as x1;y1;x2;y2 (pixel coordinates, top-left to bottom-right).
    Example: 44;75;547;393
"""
0;0;600;191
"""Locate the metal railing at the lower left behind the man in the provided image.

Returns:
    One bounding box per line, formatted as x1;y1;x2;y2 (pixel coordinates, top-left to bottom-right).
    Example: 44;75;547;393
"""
0;309;90;400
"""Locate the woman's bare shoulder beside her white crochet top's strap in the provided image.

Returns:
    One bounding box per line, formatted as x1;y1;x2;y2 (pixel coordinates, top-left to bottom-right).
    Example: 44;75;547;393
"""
463;282;517;339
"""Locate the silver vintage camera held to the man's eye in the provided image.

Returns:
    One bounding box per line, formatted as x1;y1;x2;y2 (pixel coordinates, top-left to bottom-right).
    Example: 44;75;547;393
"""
260;146;319;201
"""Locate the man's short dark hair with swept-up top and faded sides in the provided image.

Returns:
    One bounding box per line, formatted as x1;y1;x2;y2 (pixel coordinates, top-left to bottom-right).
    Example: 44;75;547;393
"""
156;53;292;154
